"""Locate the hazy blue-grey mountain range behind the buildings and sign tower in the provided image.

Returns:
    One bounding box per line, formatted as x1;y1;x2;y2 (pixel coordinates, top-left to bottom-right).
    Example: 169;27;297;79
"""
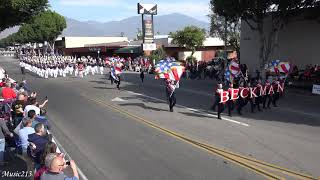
0;13;209;39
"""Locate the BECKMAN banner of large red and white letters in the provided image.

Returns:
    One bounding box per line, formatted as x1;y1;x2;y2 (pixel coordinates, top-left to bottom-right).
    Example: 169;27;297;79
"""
219;83;284;103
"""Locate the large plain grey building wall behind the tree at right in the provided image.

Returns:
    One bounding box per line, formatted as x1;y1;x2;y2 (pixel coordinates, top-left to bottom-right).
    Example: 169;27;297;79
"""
240;12;320;72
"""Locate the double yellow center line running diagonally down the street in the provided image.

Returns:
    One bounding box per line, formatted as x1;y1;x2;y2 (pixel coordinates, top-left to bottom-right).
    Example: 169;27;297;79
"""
83;95;316;180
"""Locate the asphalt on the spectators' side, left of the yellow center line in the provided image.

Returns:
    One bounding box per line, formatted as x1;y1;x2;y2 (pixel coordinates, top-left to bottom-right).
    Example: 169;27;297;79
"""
0;57;262;180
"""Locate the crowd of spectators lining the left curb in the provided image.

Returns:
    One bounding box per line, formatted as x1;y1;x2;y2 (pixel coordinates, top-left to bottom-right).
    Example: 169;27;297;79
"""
0;74;79;180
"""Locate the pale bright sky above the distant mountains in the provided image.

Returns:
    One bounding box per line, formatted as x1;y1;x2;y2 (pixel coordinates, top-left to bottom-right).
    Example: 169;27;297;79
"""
49;0;210;22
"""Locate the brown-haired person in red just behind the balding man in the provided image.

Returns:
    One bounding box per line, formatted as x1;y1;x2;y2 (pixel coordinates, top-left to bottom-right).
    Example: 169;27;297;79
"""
34;142;58;180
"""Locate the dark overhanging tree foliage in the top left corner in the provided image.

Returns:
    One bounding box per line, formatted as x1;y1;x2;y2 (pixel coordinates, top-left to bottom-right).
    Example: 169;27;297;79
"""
0;0;48;32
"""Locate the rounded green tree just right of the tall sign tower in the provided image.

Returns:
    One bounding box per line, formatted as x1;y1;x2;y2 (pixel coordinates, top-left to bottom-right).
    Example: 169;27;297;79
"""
170;26;206;59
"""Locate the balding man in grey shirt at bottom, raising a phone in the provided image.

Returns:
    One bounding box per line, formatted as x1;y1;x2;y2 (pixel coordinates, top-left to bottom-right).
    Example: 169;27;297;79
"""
40;154;79;180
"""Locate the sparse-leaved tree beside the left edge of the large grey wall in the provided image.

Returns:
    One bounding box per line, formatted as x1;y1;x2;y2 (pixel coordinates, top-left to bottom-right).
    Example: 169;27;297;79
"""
209;12;241;54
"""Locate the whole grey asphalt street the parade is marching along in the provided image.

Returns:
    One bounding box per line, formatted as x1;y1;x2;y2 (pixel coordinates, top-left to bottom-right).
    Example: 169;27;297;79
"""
0;57;320;180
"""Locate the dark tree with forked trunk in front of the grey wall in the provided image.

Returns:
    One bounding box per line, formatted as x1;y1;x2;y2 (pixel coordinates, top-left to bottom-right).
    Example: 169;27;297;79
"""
210;0;319;69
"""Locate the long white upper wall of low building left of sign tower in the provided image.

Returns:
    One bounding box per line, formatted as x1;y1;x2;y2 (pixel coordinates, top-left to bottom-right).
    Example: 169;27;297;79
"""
64;37;128;48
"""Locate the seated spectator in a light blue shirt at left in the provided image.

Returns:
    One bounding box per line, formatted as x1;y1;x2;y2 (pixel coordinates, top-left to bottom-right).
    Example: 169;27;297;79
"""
18;119;35;153
